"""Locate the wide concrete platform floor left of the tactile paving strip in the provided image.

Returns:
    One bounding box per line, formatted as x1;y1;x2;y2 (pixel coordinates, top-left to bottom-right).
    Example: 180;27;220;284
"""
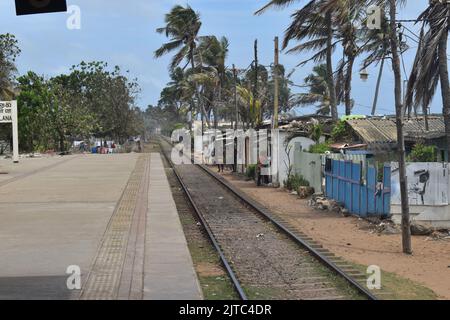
0;154;138;299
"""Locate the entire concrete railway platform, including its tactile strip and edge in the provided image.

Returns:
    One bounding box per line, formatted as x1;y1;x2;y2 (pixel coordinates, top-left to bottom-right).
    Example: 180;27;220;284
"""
0;154;202;300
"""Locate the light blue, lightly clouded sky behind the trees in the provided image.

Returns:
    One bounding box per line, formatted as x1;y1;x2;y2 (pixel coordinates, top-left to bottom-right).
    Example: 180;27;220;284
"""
0;0;442;115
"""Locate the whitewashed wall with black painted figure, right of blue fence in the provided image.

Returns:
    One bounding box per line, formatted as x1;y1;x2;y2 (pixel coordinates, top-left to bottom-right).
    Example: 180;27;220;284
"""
391;162;449;206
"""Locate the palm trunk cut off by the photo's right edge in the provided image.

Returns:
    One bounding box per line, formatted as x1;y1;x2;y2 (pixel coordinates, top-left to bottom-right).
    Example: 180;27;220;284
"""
438;14;450;162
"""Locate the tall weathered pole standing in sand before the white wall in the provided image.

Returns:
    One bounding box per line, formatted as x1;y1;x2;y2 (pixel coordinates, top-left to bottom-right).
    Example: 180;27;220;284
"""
389;0;412;254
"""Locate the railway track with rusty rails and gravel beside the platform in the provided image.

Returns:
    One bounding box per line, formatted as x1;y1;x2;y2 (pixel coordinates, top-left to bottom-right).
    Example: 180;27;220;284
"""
160;139;376;300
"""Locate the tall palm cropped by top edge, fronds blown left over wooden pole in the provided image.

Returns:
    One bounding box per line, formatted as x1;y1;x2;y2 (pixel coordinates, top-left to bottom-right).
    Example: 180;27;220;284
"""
256;0;338;120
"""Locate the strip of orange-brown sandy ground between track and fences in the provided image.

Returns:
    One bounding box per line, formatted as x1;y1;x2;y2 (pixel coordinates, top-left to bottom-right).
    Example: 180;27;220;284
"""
220;173;450;299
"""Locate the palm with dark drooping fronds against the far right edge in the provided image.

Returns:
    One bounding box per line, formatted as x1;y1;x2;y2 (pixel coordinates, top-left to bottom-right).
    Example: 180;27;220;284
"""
406;0;450;149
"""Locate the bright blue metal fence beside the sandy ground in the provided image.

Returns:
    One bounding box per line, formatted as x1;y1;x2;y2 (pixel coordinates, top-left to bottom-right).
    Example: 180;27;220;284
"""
325;159;391;217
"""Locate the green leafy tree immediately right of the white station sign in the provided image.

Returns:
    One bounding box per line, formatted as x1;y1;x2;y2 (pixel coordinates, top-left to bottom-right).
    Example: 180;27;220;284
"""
18;72;96;151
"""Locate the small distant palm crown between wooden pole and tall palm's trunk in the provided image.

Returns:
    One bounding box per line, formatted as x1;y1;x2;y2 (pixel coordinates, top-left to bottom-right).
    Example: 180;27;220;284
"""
291;64;331;115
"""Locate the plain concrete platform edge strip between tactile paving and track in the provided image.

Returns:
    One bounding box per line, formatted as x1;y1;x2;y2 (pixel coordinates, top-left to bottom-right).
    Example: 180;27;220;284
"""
143;153;202;300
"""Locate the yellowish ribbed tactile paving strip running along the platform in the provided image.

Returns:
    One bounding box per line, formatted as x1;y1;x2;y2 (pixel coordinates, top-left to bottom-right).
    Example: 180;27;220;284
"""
80;154;149;300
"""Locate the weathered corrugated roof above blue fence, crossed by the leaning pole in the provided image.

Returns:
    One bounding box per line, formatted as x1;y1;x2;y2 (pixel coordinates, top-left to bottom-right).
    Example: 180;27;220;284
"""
347;116;445;145
